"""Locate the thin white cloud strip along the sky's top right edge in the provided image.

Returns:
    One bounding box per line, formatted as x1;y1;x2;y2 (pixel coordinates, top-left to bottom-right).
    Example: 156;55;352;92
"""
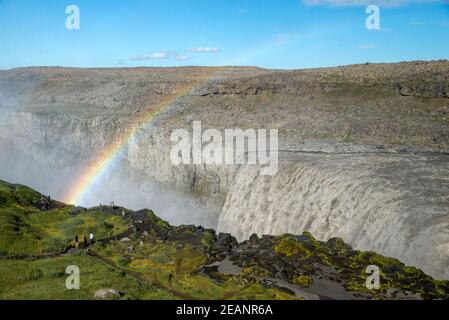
302;0;449;7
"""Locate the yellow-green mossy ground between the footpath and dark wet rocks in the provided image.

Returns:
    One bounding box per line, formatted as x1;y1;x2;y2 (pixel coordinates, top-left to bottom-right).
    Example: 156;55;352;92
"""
94;242;294;300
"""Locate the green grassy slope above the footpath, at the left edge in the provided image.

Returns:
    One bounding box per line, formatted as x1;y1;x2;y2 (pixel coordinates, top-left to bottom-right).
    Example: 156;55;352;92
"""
0;181;127;255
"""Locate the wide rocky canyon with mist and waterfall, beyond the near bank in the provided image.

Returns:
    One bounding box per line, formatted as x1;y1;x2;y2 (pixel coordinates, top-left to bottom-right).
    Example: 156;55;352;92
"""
0;61;449;279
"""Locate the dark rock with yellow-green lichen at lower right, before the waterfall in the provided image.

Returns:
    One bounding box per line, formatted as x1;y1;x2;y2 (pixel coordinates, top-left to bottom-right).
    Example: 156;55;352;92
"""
206;232;449;299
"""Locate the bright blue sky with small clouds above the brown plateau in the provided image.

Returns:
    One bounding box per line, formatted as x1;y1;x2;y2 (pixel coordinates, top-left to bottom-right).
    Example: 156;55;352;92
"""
0;0;449;69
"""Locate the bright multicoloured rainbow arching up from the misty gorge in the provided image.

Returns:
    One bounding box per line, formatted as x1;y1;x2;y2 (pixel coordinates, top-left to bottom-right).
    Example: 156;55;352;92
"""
63;68;221;205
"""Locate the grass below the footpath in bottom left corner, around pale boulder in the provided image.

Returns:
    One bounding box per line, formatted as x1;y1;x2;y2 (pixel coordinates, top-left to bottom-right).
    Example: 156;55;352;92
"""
0;254;175;300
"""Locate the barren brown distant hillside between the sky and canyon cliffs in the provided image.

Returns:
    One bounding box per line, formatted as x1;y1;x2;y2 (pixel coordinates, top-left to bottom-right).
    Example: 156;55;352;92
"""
0;61;449;152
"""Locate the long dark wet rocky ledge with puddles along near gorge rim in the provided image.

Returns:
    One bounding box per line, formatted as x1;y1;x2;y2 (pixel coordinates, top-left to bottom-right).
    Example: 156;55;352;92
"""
120;210;449;300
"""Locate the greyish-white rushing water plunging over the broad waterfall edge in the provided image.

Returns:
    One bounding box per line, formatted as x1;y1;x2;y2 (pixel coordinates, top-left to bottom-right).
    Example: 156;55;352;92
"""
218;155;449;278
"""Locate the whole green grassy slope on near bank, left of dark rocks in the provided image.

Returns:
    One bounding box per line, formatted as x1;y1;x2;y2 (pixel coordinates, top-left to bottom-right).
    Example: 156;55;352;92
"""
0;181;294;299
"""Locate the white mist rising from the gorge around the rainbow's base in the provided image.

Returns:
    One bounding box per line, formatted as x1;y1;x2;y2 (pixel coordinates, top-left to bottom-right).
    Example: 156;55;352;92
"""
0;140;218;228
